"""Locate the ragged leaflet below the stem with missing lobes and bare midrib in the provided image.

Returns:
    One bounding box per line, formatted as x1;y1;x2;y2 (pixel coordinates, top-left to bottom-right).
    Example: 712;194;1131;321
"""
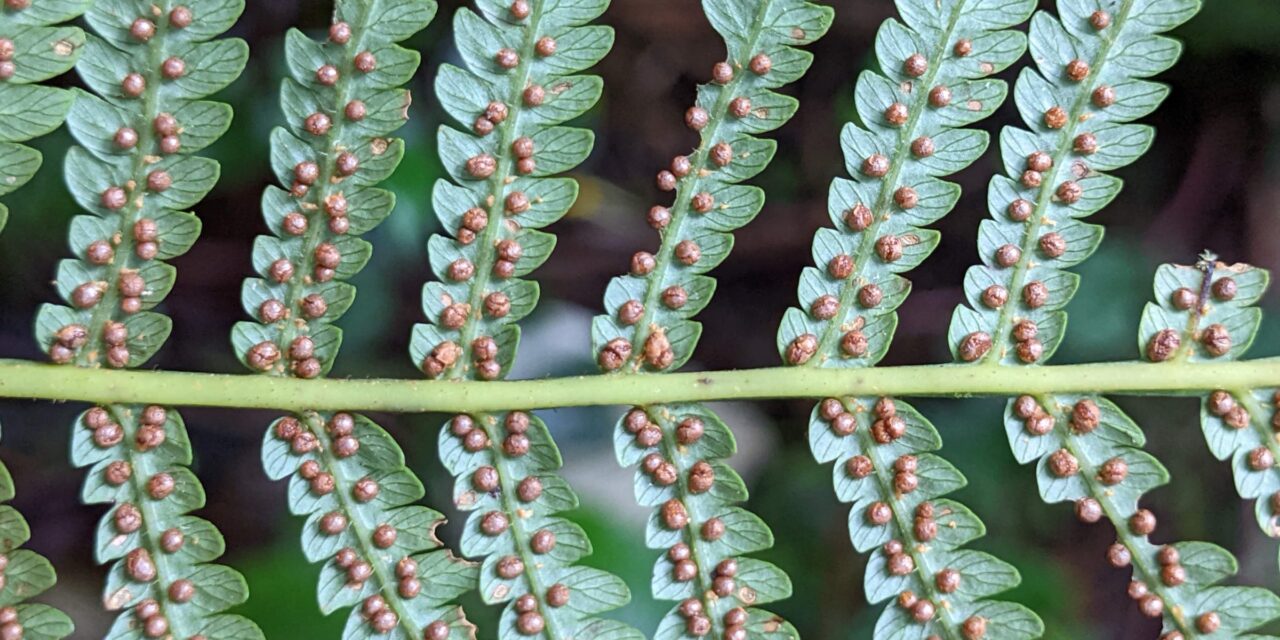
1005;396;1280;637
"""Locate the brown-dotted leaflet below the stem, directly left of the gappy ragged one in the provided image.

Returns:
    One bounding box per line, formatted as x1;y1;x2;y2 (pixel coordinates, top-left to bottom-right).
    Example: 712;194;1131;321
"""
809;398;1044;639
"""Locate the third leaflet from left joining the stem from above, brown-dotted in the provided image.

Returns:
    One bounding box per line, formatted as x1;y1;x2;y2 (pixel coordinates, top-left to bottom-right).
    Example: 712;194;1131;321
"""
410;0;613;380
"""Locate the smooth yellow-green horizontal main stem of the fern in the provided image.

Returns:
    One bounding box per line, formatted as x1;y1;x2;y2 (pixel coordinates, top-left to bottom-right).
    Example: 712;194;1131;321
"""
0;358;1280;413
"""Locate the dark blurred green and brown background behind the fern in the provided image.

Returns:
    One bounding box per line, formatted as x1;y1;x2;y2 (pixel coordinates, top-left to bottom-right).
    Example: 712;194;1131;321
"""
0;0;1280;640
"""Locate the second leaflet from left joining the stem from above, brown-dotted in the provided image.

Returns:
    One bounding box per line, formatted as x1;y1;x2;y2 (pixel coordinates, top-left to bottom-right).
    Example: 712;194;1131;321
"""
232;0;436;378
